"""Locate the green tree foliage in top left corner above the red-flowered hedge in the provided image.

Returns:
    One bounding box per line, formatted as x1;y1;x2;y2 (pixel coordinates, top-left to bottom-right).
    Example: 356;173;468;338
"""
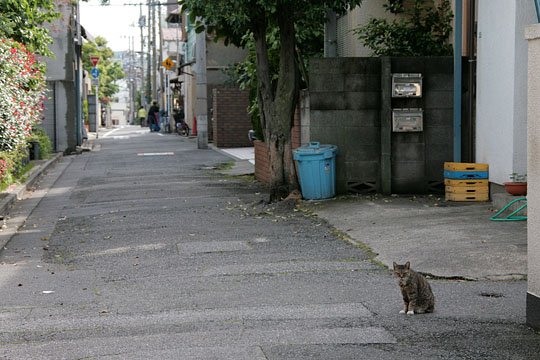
0;0;59;56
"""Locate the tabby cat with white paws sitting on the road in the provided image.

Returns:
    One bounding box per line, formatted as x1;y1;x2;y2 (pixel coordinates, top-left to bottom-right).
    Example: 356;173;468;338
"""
394;261;435;315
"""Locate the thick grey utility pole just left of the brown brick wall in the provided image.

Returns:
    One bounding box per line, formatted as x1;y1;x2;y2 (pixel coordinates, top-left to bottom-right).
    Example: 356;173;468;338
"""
195;23;208;149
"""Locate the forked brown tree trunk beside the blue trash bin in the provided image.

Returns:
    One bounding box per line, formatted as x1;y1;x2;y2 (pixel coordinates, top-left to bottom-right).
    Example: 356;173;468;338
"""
255;8;298;201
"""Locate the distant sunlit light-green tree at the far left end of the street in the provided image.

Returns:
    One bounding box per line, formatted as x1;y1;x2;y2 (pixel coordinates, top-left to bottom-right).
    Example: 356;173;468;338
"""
82;36;125;100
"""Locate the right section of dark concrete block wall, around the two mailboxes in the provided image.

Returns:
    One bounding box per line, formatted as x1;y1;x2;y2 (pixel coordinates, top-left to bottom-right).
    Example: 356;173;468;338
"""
391;57;453;193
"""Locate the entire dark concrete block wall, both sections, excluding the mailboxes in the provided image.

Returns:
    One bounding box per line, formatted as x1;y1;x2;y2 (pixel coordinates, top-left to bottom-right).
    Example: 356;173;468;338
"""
309;57;453;194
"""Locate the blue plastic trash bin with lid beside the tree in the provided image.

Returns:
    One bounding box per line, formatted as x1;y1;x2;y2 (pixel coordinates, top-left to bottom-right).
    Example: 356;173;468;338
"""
293;142;337;200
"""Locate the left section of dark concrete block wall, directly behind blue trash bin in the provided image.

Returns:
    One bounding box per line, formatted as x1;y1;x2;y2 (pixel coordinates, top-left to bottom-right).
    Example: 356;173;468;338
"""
309;58;381;194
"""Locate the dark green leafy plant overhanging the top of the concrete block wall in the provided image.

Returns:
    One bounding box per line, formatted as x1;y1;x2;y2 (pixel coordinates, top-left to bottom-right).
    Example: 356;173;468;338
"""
354;0;454;56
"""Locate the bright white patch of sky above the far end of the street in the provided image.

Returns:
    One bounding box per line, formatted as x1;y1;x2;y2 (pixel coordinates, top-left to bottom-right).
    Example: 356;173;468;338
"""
79;0;148;51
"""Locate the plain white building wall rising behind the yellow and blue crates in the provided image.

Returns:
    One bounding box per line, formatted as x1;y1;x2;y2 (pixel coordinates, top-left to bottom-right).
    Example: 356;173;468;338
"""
476;0;536;184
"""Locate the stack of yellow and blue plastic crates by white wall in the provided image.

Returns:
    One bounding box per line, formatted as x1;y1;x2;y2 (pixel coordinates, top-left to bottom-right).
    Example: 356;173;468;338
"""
444;162;489;201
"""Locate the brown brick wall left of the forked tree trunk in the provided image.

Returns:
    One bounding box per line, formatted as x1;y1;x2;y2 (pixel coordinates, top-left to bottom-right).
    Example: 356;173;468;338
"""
212;87;252;148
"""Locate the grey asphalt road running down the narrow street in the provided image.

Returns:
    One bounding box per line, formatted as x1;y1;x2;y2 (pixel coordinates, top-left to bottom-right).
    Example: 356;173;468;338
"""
0;127;540;360
